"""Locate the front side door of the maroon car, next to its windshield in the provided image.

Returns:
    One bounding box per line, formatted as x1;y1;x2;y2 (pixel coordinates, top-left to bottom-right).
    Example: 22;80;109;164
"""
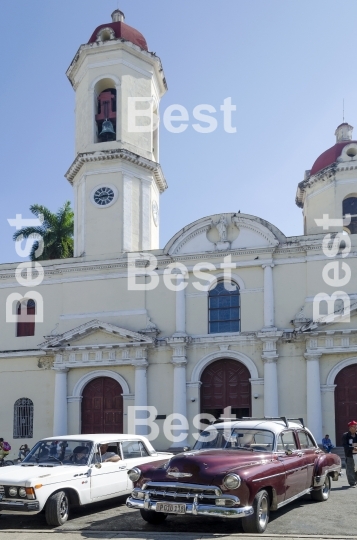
277;430;307;500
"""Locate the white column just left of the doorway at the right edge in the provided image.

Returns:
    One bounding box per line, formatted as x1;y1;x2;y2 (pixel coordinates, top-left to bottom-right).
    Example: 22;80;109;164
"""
304;353;322;443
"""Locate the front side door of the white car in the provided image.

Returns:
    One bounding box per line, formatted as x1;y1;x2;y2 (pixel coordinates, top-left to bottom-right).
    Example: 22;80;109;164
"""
90;441;128;500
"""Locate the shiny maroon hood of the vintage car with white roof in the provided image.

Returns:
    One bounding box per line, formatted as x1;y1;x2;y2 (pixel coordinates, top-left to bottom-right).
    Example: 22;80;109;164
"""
144;449;271;484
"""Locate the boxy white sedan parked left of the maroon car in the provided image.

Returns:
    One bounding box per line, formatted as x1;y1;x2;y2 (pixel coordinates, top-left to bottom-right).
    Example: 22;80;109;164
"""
0;434;172;527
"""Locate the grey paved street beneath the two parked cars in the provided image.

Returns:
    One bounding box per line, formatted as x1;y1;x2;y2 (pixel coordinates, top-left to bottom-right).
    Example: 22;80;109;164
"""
0;475;350;540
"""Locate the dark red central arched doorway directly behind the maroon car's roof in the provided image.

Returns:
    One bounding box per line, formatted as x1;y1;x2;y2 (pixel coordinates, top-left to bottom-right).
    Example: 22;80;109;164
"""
201;359;251;418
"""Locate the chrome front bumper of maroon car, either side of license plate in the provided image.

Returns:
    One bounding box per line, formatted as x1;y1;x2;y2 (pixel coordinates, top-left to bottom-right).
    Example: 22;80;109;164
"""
126;497;254;518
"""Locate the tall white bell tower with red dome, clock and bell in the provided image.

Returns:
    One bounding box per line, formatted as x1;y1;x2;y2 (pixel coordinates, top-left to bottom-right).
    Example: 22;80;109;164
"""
65;10;167;259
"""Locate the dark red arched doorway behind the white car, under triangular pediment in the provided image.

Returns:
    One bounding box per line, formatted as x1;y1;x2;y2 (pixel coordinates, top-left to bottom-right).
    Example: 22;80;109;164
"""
81;377;123;433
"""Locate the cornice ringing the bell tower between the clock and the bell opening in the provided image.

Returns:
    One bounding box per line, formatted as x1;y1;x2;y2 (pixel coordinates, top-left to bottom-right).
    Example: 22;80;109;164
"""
65;148;168;193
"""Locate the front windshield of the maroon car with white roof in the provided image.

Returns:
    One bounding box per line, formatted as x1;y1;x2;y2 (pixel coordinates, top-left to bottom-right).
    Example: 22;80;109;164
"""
193;428;274;452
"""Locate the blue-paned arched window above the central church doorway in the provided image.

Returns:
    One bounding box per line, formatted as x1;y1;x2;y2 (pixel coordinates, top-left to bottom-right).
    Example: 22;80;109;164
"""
208;281;240;334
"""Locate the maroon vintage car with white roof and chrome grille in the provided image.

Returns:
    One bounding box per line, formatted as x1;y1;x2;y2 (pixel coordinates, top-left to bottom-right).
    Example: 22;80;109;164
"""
127;417;341;533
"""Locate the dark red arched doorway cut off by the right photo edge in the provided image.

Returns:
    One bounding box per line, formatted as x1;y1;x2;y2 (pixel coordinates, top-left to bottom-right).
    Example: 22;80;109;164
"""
335;364;357;446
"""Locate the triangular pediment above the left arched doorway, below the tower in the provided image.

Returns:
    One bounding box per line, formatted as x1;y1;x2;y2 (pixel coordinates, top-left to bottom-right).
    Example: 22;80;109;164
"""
40;320;152;349
